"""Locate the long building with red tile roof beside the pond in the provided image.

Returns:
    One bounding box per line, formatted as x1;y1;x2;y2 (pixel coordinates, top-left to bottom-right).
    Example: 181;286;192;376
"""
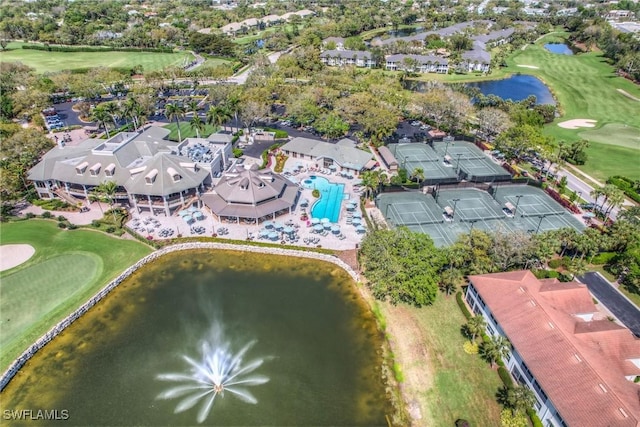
466;271;640;427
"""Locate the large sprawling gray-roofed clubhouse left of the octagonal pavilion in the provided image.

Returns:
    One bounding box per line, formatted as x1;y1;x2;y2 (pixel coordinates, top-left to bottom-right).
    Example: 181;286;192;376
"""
28;127;232;216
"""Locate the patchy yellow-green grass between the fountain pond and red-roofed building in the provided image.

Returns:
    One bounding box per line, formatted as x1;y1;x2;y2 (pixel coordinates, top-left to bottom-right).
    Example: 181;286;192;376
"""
382;295;502;427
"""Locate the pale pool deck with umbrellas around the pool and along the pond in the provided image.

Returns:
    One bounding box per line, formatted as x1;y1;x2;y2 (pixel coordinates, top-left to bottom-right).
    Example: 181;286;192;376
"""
122;158;366;250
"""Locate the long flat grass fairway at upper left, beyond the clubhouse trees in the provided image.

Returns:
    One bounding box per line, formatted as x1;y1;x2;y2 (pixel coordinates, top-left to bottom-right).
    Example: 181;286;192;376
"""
0;43;193;73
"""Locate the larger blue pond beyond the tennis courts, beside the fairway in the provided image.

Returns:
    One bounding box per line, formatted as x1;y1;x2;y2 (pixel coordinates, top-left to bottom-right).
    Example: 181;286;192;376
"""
468;74;556;105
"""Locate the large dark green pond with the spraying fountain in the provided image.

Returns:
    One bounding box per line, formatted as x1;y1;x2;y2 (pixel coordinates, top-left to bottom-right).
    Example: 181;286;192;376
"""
2;250;393;426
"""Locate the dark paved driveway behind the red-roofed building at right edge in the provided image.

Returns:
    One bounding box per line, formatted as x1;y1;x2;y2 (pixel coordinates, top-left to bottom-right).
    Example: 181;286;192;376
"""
578;273;640;337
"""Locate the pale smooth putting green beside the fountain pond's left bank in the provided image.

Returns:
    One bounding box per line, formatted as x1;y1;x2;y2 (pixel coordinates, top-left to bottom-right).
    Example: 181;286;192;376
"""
0;252;102;348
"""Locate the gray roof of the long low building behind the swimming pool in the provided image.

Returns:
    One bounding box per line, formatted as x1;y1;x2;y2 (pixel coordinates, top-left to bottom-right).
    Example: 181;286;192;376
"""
280;137;373;171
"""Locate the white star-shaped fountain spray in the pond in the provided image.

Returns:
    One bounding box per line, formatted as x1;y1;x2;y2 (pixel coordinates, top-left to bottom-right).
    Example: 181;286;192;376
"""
157;325;269;423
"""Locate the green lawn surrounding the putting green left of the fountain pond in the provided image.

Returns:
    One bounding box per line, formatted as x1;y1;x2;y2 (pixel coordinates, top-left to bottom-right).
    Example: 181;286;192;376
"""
0;219;152;370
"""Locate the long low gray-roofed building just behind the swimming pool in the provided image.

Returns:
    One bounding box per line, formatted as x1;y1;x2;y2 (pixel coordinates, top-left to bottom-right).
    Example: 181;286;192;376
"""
280;137;376;175
